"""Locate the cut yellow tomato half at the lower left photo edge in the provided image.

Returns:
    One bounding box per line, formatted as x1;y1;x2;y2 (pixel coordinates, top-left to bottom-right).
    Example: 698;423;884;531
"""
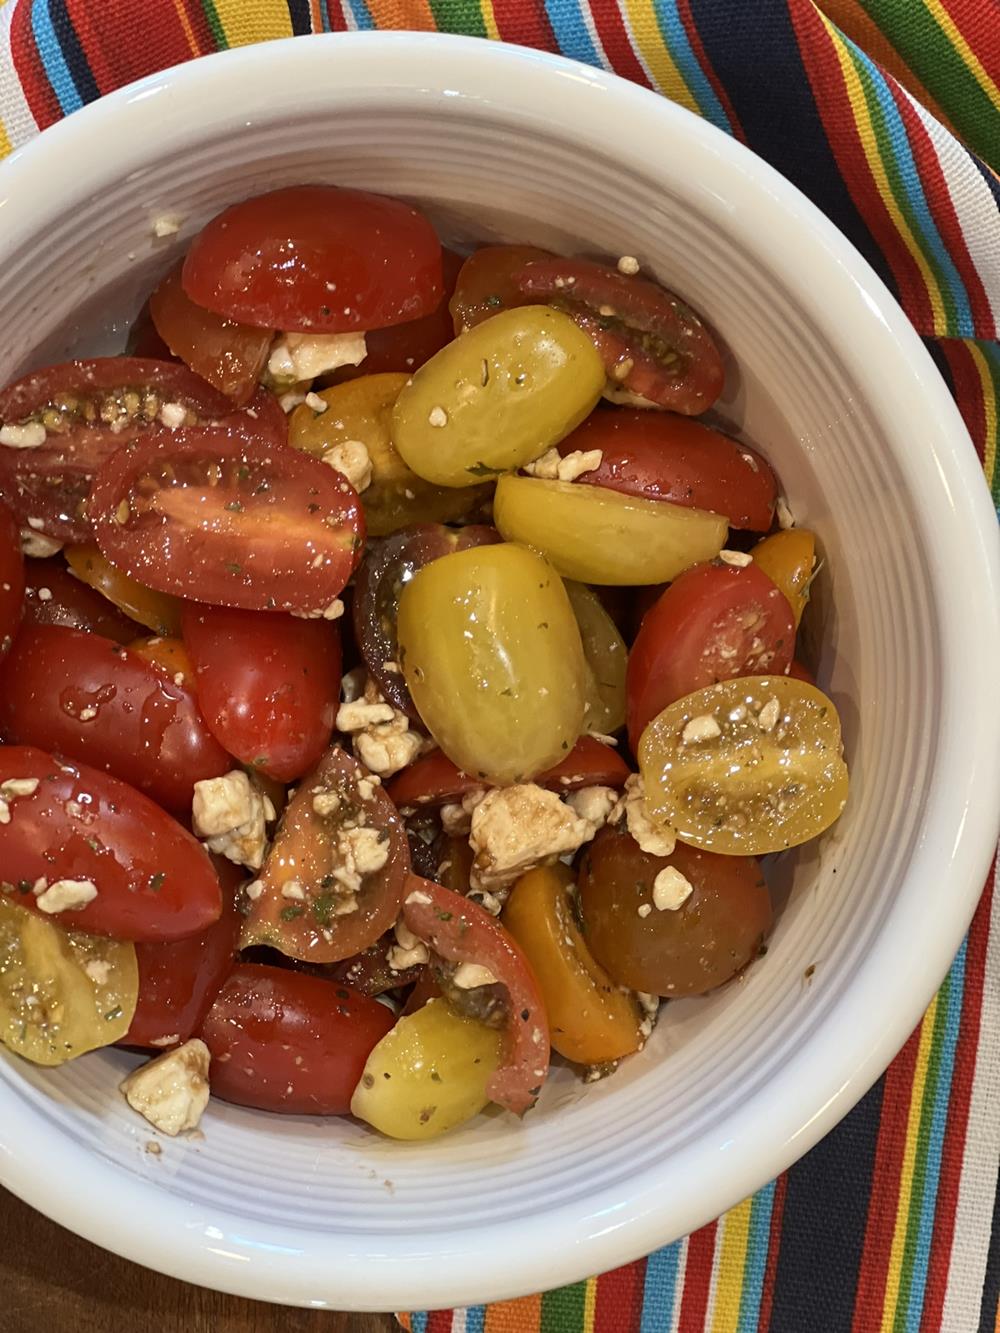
0;885;139;1065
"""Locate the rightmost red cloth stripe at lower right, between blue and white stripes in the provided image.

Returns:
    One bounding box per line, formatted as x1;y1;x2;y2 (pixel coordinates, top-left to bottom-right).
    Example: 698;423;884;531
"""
920;873;993;1333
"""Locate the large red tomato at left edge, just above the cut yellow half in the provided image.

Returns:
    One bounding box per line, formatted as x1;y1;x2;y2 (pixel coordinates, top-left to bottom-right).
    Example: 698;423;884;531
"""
0;745;221;940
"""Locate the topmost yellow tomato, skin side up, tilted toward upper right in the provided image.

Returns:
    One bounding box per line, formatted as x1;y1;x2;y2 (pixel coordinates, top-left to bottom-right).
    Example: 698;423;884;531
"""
392;305;605;487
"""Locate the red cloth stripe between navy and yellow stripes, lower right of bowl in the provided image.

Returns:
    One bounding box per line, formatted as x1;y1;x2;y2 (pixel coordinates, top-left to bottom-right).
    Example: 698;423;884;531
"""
851;1028;920;1333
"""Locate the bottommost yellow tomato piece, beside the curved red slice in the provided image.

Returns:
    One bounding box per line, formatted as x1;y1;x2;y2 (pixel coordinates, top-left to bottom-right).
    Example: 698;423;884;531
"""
351;998;504;1138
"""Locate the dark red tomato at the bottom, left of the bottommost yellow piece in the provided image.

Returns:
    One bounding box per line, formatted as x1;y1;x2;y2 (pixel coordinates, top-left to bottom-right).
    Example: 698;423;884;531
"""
200;962;396;1116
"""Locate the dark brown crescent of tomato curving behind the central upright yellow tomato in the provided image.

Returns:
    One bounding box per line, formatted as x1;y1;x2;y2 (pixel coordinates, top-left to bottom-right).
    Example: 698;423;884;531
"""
353;523;500;721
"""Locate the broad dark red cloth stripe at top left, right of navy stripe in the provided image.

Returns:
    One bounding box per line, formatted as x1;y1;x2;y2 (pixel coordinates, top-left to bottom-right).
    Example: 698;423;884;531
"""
65;0;197;95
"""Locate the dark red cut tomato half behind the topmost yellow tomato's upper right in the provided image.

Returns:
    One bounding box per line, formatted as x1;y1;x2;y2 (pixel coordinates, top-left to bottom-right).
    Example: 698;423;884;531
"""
515;259;725;416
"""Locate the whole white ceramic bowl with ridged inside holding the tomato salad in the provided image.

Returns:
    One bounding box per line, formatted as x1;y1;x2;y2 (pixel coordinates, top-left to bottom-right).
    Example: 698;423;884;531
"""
0;35;1000;1309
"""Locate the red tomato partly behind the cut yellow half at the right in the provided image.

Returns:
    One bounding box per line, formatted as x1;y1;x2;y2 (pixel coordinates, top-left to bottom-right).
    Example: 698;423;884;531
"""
625;564;795;749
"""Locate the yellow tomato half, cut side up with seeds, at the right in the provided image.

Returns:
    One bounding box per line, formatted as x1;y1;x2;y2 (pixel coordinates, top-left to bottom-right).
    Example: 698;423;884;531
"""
639;676;848;856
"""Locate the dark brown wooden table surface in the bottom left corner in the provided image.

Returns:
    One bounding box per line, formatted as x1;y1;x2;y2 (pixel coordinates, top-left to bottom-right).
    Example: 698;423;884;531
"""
0;1190;399;1333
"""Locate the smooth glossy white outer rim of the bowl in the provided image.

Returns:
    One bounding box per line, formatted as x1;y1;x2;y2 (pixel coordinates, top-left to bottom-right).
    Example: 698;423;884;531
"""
0;32;1000;1310
